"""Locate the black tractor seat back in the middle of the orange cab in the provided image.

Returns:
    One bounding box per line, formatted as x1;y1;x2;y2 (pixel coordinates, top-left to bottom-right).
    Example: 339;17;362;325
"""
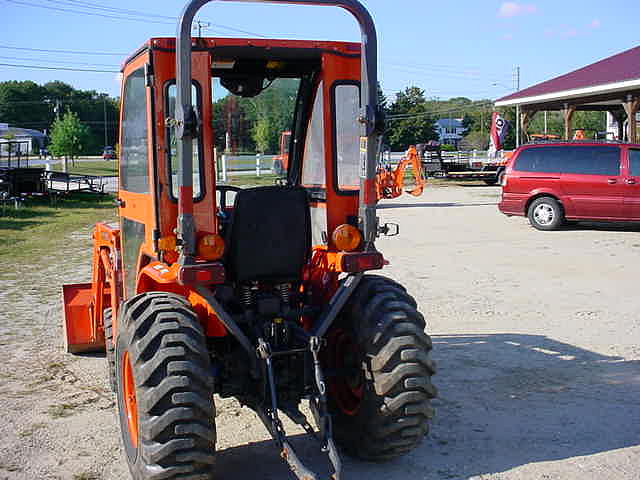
225;186;311;283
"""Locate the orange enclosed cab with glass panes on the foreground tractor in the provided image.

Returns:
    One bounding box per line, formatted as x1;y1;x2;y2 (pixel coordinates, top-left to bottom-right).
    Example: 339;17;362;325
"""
118;38;365;296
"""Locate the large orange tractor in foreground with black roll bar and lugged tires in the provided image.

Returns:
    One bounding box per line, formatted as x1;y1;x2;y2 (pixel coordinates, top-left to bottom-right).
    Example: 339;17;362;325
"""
63;0;436;480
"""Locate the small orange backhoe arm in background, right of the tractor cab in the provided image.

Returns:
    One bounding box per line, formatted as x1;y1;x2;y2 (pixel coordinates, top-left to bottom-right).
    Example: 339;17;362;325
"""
376;145;426;200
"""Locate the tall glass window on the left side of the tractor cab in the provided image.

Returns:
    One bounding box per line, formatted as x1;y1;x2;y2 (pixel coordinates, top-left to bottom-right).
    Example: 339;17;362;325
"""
120;68;149;193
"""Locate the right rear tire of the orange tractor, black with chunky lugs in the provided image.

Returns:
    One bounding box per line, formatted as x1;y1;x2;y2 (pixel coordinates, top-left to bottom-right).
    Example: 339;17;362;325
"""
327;275;437;461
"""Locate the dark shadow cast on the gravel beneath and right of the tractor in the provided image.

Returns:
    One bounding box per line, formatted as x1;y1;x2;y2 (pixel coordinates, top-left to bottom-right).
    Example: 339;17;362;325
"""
211;334;640;480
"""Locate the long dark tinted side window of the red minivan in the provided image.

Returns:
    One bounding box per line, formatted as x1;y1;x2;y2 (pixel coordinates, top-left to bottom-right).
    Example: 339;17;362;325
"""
514;146;620;176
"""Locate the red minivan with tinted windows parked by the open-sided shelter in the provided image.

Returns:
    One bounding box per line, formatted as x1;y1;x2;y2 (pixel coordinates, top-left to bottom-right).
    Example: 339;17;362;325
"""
498;142;640;230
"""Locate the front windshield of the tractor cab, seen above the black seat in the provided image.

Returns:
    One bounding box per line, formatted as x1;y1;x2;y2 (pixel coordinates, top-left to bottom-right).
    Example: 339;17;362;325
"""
212;72;301;188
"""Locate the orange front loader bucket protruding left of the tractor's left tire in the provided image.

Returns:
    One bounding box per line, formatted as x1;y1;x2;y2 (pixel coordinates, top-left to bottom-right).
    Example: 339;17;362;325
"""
62;283;105;353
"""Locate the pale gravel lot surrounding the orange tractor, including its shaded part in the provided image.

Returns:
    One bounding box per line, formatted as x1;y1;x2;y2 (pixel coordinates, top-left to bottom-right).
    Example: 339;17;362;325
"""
0;186;640;480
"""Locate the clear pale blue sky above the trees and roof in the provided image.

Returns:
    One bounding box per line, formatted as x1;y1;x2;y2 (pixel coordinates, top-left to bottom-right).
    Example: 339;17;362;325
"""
0;0;640;99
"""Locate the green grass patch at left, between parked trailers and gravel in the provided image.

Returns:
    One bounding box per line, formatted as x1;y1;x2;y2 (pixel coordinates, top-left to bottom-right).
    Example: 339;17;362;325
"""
0;193;116;267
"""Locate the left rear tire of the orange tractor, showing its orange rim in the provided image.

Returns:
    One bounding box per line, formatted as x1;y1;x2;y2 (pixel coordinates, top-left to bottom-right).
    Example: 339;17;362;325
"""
116;292;216;480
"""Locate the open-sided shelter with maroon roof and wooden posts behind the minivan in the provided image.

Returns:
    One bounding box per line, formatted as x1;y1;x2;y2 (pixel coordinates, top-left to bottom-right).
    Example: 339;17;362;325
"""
495;46;640;142
